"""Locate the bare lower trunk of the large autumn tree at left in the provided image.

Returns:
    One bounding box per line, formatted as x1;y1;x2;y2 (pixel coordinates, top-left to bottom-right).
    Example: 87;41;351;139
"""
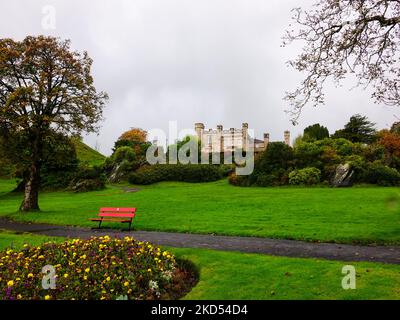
20;162;40;212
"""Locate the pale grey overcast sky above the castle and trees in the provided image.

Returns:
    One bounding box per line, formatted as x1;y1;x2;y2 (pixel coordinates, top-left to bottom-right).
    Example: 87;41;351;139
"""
0;0;398;154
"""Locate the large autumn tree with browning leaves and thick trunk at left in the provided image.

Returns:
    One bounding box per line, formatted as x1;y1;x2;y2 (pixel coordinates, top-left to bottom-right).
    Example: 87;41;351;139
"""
0;36;107;211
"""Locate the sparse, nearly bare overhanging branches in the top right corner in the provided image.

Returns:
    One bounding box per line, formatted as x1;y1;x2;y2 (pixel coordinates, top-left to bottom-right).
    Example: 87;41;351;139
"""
284;0;400;123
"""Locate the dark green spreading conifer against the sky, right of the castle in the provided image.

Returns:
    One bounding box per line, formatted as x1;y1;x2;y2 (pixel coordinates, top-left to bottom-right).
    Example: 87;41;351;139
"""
333;114;377;144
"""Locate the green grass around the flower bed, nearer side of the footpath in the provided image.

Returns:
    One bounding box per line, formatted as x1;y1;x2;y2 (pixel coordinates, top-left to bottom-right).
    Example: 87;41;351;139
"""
0;231;400;300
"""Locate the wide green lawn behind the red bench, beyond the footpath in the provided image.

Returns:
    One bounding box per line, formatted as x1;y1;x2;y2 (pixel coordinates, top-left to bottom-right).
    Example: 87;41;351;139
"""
0;180;400;244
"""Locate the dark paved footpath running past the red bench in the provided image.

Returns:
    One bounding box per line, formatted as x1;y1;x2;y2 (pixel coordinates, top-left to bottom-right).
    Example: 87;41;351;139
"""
0;218;400;264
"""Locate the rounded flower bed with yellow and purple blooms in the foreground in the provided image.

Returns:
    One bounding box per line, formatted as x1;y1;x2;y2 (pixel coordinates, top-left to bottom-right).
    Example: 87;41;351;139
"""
0;236;197;300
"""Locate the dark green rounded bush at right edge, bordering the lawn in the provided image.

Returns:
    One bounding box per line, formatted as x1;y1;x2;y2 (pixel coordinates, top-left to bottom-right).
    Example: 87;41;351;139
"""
363;161;400;186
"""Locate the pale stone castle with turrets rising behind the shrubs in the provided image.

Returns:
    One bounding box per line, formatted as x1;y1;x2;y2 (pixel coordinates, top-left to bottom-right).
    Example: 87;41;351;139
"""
195;123;290;153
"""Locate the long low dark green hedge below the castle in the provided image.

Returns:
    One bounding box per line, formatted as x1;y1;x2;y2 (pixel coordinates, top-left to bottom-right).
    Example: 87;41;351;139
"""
129;164;230;185
